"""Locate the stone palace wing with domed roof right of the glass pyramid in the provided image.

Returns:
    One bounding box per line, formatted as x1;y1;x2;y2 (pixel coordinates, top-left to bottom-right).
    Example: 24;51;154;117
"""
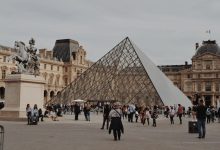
159;40;220;106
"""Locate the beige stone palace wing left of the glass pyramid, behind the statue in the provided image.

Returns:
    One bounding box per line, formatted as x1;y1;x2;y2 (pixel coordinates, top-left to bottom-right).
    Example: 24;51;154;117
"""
0;39;92;103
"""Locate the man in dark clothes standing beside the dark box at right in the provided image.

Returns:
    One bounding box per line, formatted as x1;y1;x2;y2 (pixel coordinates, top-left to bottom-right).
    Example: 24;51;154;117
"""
196;100;207;138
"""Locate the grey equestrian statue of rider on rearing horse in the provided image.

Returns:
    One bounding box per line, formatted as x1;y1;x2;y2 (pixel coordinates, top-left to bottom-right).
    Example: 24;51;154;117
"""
8;38;40;76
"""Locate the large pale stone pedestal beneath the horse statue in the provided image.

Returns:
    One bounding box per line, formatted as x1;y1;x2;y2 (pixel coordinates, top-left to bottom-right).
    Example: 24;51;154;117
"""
0;74;45;120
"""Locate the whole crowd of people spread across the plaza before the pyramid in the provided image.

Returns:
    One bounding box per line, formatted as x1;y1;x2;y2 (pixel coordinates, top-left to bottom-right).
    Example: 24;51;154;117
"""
26;100;220;141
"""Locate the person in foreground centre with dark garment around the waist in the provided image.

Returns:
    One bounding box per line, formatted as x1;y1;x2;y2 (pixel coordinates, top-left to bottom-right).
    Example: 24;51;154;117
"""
109;102;124;141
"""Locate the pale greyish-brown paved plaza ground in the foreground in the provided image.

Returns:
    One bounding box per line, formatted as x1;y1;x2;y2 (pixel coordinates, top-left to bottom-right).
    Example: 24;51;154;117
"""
0;113;220;150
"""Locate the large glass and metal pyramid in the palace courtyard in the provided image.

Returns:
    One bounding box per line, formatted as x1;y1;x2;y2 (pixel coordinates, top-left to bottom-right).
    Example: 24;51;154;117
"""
50;37;191;107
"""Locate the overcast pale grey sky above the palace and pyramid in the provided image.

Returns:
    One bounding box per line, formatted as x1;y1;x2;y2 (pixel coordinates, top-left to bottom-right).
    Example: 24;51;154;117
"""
0;0;220;65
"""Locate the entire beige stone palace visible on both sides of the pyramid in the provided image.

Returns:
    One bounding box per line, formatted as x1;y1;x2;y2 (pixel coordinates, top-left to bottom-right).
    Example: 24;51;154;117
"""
0;39;220;106
